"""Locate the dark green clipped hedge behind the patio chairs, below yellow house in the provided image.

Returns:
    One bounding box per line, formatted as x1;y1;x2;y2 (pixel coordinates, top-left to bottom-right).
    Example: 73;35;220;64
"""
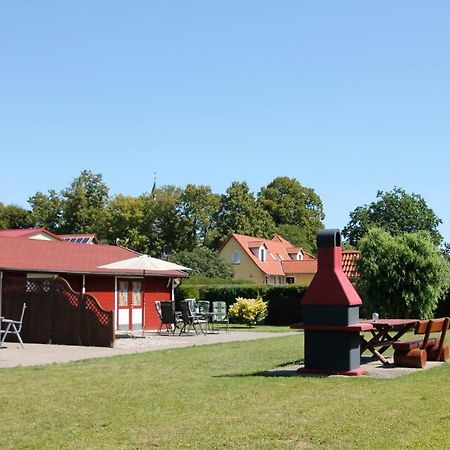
175;284;307;325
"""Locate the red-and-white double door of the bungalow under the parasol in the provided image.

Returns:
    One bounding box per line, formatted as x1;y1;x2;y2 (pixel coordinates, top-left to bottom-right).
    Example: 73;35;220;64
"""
117;280;143;331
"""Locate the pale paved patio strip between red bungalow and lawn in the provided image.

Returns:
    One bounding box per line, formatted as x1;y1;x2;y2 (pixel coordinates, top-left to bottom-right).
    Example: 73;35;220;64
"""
0;331;298;369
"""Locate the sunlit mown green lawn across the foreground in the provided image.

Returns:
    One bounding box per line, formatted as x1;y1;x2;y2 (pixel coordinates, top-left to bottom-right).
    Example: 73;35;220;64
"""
0;333;450;450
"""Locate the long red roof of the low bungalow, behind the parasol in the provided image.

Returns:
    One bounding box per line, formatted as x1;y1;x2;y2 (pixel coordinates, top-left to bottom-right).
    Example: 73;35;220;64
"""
0;235;186;277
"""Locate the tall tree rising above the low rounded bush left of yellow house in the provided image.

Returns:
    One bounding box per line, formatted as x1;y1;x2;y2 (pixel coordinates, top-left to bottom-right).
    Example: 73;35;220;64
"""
178;184;220;251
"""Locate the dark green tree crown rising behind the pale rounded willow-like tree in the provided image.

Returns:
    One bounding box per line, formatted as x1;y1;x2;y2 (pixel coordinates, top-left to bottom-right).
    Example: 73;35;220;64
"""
342;187;442;245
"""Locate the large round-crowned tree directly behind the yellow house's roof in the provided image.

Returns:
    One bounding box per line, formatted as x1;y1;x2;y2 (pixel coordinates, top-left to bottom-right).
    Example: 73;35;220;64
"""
258;177;325;249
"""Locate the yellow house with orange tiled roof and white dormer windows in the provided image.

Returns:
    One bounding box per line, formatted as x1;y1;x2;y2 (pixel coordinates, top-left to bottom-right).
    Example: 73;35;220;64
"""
219;234;317;284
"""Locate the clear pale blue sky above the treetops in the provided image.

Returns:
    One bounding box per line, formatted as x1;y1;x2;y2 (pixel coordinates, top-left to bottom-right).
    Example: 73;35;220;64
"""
0;0;450;241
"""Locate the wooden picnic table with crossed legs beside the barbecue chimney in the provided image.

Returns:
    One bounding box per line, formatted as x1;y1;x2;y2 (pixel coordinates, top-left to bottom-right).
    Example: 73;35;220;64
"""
360;319;419;365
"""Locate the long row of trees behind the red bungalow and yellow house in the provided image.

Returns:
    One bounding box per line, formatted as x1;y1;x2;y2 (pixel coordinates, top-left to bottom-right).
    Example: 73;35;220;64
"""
0;170;323;264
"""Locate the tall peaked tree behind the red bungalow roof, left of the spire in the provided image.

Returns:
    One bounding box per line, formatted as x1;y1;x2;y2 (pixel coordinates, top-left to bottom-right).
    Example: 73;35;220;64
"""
61;170;109;233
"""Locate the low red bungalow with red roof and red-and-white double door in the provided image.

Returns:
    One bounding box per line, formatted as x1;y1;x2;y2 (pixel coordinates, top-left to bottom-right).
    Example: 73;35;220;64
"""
0;229;188;344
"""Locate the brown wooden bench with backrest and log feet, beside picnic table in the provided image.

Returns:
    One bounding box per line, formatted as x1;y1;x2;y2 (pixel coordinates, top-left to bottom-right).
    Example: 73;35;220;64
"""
392;317;450;368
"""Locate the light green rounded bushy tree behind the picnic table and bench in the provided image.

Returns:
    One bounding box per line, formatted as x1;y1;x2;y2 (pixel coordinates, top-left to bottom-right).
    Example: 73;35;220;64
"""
357;228;448;318
